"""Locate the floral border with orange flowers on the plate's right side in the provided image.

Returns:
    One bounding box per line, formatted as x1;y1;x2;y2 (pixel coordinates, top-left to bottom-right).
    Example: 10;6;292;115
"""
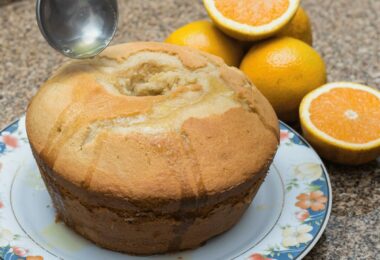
248;127;331;260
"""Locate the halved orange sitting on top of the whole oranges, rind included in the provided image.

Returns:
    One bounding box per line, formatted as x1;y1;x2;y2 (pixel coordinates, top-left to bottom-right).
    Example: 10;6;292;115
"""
203;0;300;41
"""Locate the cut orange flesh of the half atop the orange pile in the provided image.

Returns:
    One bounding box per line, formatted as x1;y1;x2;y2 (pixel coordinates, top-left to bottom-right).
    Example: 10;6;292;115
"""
215;0;289;26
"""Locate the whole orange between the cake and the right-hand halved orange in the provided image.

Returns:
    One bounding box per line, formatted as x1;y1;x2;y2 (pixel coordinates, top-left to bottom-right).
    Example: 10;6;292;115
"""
240;37;326;122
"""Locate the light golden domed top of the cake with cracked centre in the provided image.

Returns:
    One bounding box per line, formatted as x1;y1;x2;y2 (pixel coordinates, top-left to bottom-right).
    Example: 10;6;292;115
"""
26;40;279;213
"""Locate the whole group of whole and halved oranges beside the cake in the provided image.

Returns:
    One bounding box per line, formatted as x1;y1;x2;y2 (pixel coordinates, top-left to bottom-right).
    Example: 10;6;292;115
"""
165;0;380;164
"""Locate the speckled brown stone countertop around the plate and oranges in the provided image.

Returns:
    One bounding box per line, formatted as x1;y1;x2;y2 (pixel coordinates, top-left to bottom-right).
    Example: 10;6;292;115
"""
0;0;380;259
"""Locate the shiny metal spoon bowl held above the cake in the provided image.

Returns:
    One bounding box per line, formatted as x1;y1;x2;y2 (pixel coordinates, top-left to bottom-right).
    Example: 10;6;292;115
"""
36;0;118;59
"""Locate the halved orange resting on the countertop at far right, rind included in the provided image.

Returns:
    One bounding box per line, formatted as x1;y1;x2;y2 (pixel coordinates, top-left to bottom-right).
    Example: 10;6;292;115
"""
300;82;380;165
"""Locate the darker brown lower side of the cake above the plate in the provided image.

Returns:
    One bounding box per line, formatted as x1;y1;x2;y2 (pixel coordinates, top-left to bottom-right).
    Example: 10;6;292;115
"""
36;148;267;255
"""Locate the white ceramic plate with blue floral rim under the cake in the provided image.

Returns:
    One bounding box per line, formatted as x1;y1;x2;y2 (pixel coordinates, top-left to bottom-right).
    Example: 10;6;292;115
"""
0;118;331;260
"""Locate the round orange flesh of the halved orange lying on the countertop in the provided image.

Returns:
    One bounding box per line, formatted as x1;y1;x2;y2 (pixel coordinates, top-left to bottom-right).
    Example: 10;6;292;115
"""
309;88;380;144
